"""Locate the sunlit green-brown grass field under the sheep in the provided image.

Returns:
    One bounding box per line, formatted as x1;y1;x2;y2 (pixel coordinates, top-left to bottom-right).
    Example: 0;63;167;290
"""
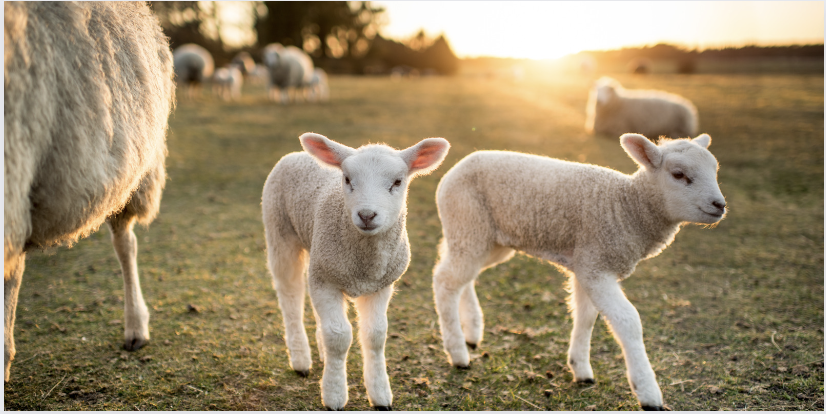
4;75;824;410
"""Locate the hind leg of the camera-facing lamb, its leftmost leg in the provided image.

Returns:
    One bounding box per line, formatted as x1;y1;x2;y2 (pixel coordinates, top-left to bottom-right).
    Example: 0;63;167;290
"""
267;241;312;377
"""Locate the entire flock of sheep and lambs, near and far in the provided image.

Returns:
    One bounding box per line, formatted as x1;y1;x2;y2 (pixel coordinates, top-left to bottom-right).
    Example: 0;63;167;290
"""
4;2;726;410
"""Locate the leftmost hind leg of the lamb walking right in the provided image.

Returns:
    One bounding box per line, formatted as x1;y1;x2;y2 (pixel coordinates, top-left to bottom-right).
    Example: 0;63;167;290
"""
433;253;482;369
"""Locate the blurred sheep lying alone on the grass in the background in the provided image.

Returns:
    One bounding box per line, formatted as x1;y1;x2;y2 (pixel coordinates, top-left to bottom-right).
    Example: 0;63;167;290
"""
585;77;698;138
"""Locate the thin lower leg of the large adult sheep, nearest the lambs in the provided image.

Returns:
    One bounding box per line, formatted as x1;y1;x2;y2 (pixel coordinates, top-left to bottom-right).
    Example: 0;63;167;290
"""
107;213;149;351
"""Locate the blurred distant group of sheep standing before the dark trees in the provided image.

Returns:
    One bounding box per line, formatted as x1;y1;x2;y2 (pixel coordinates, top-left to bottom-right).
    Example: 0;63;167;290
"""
172;43;330;104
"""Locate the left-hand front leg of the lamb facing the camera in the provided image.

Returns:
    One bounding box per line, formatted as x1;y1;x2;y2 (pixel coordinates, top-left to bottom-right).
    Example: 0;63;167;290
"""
310;284;353;410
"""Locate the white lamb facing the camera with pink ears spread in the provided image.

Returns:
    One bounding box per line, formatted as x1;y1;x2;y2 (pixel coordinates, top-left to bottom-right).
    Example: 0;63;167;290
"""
261;133;450;409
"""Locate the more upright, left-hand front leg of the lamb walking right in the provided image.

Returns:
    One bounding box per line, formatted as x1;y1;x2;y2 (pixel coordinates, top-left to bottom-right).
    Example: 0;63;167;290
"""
568;275;599;383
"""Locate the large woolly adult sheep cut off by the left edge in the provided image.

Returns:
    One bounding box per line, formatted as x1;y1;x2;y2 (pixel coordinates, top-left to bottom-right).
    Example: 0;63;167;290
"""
3;2;175;381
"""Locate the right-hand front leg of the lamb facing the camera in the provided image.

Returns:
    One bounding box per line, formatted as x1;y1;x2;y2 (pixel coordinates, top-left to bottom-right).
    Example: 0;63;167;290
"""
355;285;393;409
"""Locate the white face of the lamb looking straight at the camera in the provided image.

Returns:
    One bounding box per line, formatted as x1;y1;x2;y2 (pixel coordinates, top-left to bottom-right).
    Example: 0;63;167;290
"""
341;147;409;235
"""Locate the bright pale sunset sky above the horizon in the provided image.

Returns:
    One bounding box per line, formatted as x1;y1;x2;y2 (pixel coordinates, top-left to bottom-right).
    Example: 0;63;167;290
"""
374;1;824;59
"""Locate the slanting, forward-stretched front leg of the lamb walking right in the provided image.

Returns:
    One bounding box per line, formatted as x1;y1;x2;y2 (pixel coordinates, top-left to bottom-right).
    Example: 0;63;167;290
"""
577;274;663;409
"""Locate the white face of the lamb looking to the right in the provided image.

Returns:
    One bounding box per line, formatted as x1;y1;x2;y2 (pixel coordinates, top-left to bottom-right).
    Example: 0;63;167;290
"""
657;140;726;224
